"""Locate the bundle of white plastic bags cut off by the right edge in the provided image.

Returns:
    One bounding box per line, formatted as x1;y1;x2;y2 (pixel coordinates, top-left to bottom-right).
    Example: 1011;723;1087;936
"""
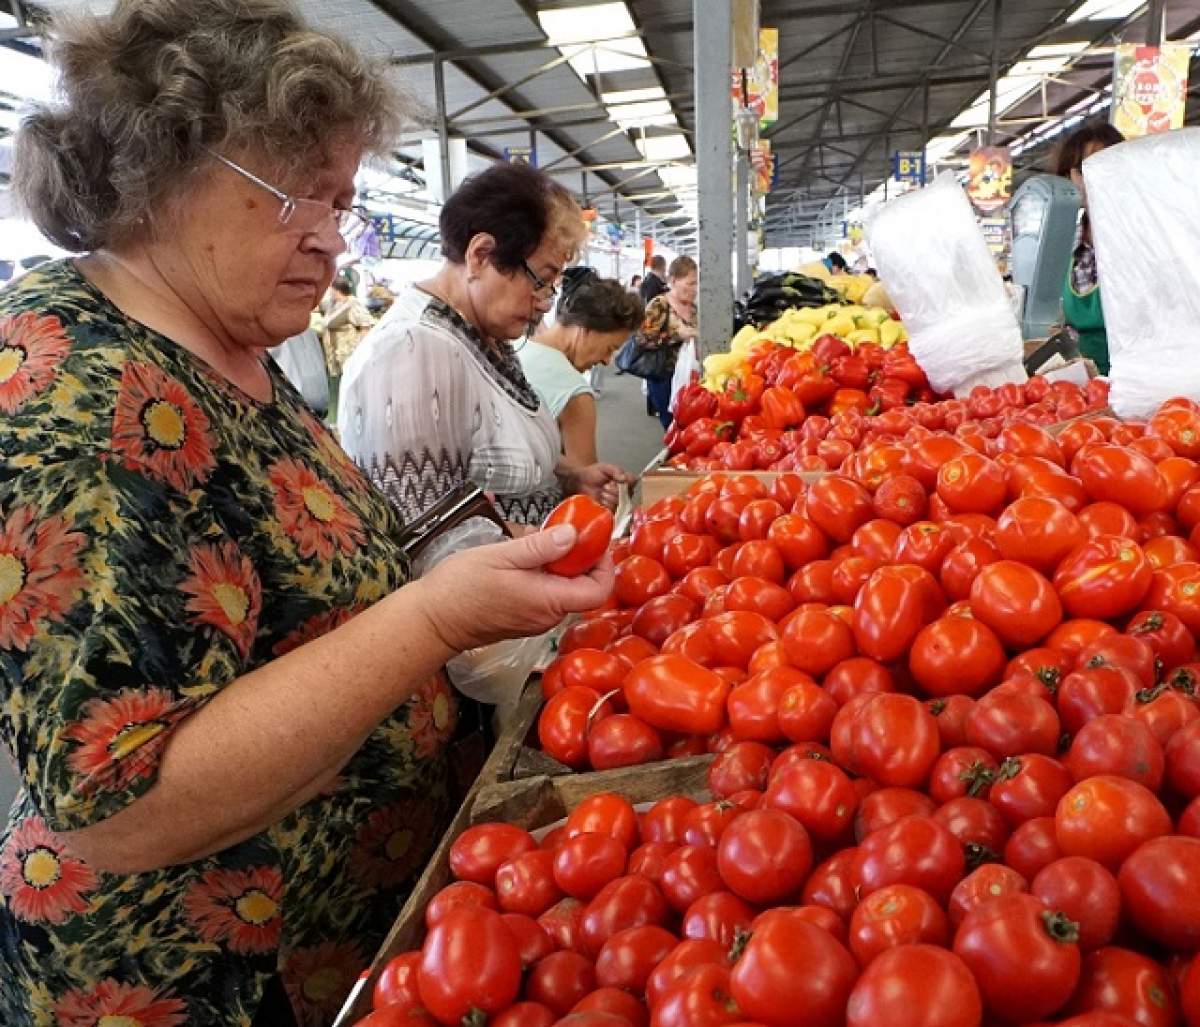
1084;128;1200;418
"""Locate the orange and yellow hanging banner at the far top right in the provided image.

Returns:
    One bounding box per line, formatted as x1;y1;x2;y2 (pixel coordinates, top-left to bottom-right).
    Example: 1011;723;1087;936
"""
1112;43;1192;139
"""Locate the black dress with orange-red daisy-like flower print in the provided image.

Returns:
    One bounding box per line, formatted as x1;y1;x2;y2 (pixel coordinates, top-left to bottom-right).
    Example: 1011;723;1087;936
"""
0;263;458;1027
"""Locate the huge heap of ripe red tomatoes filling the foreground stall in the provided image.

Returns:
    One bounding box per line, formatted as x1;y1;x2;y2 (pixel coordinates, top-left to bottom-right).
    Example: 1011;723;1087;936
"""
361;398;1200;1027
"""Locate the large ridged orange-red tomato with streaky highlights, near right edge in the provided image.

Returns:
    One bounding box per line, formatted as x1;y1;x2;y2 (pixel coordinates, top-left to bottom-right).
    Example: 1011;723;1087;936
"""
1054;535;1153;620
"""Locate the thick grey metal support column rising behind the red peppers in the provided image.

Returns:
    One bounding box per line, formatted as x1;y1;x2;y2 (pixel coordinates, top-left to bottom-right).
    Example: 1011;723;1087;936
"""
692;0;733;358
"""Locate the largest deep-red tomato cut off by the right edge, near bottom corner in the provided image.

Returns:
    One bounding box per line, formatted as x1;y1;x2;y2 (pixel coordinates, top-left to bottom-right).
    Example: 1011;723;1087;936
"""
1120;836;1200;951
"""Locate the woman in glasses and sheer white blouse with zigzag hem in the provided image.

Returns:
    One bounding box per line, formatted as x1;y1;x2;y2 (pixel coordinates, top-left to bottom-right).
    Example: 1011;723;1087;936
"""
338;163;626;524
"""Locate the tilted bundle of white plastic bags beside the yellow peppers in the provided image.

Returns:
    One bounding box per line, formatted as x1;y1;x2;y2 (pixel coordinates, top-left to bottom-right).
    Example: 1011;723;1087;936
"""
866;174;1026;395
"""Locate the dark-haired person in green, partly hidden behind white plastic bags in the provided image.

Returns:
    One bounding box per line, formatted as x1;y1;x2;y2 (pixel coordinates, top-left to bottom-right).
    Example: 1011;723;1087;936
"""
1055;121;1124;374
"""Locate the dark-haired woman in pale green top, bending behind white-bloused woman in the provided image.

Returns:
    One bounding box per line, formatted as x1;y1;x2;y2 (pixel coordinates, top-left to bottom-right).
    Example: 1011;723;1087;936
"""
517;271;642;466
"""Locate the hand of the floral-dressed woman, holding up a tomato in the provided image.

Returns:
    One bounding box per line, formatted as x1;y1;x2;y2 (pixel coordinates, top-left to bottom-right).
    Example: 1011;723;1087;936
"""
407;524;612;653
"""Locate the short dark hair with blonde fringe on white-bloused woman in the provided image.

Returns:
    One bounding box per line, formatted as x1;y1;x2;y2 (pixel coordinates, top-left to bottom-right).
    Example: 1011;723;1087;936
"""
438;161;584;271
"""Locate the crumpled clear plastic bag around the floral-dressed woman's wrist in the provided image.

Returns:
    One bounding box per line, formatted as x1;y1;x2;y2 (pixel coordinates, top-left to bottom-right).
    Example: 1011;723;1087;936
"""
413;517;551;709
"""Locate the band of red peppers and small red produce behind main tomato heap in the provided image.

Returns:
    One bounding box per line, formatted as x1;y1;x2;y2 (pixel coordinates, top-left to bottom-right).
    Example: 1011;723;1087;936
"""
665;347;1109;472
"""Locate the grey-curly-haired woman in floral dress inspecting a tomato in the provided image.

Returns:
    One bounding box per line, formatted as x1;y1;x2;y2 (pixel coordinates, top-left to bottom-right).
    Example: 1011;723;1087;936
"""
0;0;611;1027
